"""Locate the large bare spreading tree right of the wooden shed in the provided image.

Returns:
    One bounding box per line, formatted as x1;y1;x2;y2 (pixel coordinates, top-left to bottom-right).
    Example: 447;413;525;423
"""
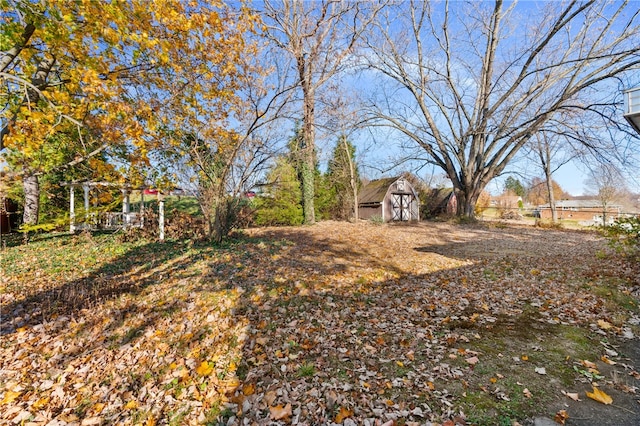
365;0;640;216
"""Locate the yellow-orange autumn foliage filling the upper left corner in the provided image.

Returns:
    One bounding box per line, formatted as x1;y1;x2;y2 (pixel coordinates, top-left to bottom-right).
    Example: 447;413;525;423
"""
0;0;258;188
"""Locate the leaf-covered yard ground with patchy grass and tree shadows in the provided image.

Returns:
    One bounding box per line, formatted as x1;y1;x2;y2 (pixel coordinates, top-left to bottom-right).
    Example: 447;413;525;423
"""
0;222;640;425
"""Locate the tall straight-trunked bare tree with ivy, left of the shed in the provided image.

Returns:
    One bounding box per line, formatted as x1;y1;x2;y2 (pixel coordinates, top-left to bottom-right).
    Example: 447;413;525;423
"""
264;0;381;224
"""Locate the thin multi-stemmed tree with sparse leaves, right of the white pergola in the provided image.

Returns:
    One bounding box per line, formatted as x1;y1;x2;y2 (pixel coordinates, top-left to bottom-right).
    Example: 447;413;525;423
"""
160;43;294;243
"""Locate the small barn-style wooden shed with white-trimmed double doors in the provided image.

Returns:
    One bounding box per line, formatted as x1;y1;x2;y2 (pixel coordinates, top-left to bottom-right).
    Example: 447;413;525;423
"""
358;177;420;222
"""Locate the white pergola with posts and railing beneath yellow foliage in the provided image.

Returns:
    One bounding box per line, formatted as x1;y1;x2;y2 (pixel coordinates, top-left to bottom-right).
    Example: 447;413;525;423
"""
62;181;164;240
